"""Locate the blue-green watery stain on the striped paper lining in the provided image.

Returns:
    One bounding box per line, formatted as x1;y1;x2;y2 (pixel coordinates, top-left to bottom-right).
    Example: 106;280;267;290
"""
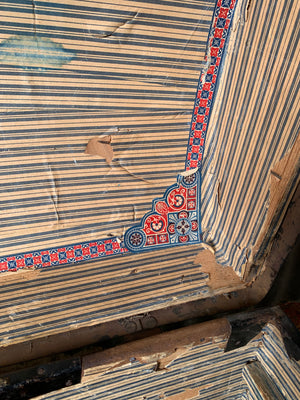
0;35;76;70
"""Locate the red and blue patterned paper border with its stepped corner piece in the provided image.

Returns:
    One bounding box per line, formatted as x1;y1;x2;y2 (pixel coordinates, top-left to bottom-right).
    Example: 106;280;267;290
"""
0;0;237;272
